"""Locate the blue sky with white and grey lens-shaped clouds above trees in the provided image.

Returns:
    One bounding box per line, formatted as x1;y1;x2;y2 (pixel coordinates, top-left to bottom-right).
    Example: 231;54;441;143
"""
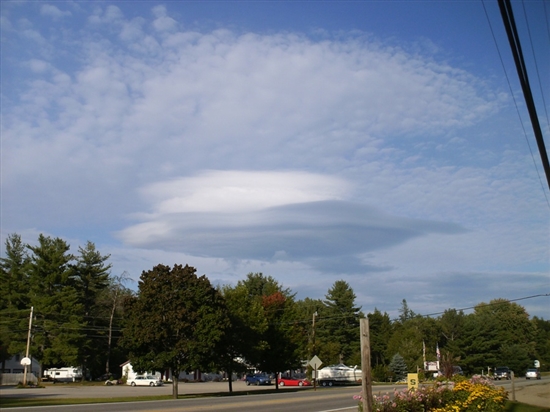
1;0;550;319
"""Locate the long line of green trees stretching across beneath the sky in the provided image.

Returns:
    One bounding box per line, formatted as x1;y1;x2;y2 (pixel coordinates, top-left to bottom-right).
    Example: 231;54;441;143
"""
0;234;550;391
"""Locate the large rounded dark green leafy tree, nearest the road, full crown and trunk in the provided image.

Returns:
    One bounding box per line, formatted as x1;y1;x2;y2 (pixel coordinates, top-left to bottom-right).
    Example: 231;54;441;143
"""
123;265;227;398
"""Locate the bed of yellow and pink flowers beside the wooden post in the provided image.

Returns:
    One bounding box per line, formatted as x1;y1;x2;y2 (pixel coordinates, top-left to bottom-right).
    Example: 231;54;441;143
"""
354;376;508;412
